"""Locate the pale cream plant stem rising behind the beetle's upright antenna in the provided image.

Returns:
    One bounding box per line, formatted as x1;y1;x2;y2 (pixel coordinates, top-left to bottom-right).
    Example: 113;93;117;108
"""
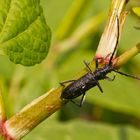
95;0;128;58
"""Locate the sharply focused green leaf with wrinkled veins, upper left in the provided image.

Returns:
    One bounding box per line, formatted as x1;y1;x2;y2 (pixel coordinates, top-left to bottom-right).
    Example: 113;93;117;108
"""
0;0;51;66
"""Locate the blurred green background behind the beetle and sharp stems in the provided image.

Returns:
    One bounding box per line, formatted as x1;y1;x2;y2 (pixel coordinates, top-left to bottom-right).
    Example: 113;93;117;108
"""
0;0;140;140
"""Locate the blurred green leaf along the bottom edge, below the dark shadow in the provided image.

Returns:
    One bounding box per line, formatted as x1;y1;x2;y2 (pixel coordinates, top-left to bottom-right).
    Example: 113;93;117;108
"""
24;120;140;140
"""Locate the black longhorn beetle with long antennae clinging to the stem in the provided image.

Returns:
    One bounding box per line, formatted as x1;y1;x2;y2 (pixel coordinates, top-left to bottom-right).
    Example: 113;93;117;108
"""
60;10;140;107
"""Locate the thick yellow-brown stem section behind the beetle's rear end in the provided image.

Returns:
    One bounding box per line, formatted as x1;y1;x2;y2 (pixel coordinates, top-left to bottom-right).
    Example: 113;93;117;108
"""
5;87;65;140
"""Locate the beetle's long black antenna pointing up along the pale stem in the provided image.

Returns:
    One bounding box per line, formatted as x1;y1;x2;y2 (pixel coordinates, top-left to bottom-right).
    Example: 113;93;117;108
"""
108;12;120;65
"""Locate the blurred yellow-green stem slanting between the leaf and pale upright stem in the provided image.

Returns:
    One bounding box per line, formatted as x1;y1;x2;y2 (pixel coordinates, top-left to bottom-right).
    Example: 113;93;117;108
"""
58;13;105;53
